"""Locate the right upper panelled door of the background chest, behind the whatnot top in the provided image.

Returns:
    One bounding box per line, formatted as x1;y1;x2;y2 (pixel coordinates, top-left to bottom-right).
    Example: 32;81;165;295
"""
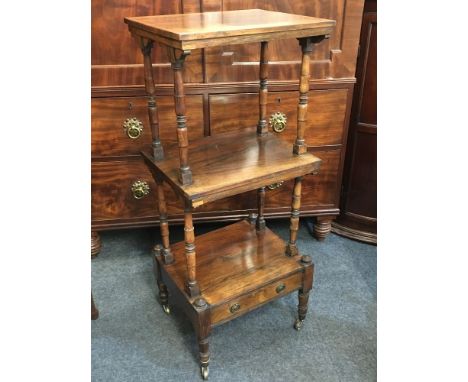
203;0;363;82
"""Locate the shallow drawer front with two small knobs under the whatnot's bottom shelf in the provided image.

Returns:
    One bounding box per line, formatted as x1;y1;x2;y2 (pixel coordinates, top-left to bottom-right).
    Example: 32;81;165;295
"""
211;272;302;325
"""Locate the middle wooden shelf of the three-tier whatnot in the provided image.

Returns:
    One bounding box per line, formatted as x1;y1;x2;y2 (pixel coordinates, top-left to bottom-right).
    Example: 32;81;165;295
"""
142;129;321;207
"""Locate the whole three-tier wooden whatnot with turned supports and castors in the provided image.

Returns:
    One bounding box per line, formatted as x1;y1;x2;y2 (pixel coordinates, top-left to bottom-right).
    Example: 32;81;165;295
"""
125;9;335;379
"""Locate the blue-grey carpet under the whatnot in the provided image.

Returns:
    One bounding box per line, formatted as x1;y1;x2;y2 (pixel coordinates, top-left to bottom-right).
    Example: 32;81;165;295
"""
92;220;377;382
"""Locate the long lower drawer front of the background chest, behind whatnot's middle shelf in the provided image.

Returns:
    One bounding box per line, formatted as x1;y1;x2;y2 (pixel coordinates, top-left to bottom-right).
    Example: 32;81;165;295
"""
91;149;341;229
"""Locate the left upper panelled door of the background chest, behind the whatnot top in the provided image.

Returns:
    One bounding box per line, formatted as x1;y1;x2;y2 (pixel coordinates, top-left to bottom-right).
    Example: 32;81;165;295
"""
91;0;202;87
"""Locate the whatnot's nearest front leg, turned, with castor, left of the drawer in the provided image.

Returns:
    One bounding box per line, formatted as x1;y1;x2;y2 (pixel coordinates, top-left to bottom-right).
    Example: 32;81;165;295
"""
193;298;211;380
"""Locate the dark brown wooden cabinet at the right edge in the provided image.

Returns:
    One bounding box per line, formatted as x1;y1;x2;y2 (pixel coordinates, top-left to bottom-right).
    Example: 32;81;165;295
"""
333;0;377;243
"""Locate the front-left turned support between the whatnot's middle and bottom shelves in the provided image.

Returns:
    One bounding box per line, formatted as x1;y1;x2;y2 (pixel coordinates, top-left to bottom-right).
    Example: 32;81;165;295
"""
184;202;200;297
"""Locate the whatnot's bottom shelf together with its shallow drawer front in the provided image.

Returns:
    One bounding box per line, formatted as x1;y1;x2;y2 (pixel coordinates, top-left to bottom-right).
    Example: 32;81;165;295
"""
156;220;305;326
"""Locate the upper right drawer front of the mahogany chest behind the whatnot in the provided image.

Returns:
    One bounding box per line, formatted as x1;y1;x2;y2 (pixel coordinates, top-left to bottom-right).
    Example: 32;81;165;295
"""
210;89;348;146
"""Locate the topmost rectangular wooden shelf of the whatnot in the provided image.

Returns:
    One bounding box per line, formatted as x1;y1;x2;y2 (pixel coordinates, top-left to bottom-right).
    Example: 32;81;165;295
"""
125;9;335;50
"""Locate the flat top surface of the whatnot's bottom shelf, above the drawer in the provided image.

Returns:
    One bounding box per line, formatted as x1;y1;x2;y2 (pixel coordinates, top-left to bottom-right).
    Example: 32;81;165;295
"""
164;220;302;305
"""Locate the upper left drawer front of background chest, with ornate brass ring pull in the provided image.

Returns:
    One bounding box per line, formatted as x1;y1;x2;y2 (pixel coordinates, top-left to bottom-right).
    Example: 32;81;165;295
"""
91;95;204;157
